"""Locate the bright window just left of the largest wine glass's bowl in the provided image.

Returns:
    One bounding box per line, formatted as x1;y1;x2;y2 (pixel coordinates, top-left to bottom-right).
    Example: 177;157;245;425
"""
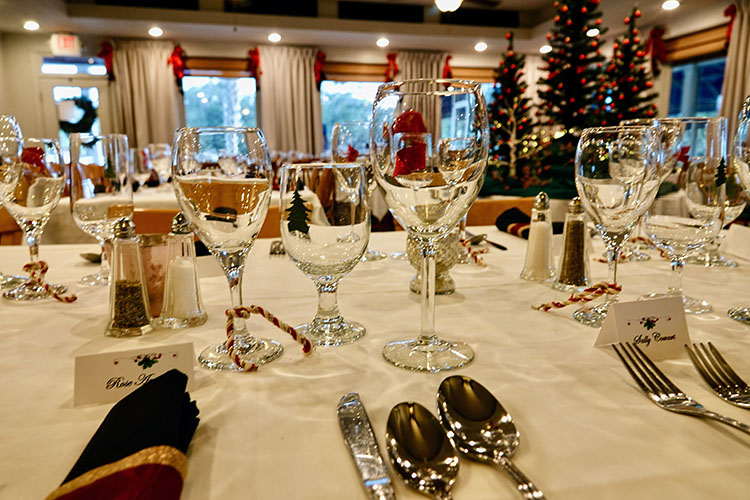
320;80;381;149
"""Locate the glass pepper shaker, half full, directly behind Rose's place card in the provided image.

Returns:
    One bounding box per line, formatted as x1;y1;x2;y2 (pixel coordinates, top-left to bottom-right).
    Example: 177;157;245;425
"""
104;217;154;337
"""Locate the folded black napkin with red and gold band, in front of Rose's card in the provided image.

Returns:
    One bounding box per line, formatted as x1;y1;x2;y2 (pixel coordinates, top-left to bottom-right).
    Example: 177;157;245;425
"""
47;370;199;500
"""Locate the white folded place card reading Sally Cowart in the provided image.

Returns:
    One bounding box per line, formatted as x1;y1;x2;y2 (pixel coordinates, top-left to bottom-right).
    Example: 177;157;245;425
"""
594;297;690;359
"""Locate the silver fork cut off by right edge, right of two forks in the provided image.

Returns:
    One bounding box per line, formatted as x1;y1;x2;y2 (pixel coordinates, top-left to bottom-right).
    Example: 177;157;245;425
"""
685;342;750;409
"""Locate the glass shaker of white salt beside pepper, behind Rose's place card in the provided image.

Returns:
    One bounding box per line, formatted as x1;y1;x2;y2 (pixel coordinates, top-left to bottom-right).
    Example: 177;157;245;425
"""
160;212;208;328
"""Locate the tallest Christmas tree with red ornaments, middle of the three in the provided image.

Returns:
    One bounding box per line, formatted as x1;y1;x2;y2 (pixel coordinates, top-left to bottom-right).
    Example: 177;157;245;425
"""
539;0;606;132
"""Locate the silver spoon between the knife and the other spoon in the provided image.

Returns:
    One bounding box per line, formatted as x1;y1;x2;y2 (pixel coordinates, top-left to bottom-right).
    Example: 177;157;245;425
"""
385;403;459;500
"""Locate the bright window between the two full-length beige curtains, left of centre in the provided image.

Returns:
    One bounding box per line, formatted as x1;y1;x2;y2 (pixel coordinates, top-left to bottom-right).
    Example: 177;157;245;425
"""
182;76;258;127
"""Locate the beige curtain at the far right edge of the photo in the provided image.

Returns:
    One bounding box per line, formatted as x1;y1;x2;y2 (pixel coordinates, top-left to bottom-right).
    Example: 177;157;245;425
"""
721;0;750;144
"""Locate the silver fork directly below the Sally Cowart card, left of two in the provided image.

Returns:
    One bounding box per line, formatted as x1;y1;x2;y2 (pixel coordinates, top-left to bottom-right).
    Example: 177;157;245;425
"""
612;342;750;434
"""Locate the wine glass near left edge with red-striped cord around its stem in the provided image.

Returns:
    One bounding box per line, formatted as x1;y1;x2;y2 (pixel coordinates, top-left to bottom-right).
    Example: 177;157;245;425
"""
0;137;66;301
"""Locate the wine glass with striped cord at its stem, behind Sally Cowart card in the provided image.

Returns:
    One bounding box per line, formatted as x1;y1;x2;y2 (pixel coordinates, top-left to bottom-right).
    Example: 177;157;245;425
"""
573;127;661;328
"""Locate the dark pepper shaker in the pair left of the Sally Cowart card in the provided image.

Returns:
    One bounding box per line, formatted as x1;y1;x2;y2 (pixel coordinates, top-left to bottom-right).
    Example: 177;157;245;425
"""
552;196;589;292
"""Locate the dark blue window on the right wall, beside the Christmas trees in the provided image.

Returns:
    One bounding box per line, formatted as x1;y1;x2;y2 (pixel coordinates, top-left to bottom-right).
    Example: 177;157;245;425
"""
669;57;726;117
